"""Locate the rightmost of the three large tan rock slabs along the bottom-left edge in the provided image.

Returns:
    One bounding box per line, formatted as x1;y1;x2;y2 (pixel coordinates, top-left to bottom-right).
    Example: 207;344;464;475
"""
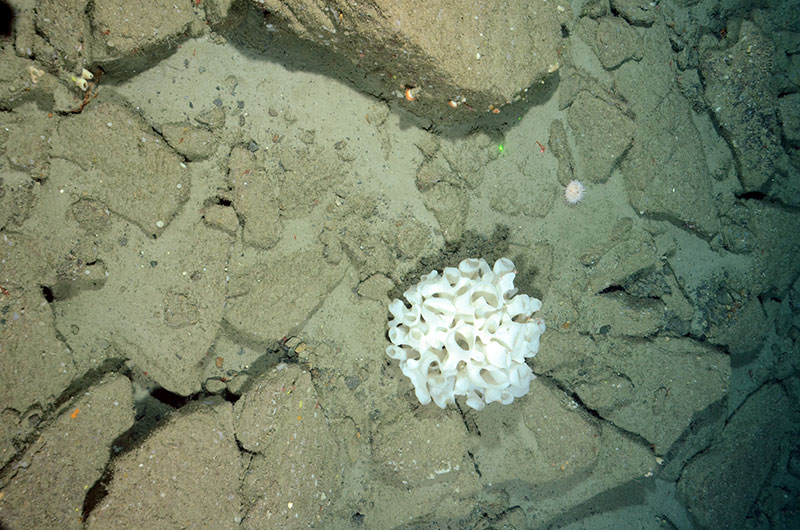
234;364;344;530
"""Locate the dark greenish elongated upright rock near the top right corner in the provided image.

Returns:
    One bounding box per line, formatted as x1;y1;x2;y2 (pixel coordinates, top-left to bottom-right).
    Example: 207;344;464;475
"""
700;20;782;191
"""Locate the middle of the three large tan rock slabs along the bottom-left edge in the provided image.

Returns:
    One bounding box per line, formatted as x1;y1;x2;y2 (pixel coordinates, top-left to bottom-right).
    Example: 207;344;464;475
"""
86;398;242;530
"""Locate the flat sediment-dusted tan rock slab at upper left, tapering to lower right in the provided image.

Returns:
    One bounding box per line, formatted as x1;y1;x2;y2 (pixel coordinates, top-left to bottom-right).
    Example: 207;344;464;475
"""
52;103;190;235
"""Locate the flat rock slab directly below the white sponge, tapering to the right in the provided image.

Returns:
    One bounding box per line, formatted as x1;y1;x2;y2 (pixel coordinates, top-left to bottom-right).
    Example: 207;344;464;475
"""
467;379;656;528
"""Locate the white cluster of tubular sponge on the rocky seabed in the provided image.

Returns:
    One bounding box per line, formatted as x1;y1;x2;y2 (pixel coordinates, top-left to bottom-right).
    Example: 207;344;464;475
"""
386;258;545;410
